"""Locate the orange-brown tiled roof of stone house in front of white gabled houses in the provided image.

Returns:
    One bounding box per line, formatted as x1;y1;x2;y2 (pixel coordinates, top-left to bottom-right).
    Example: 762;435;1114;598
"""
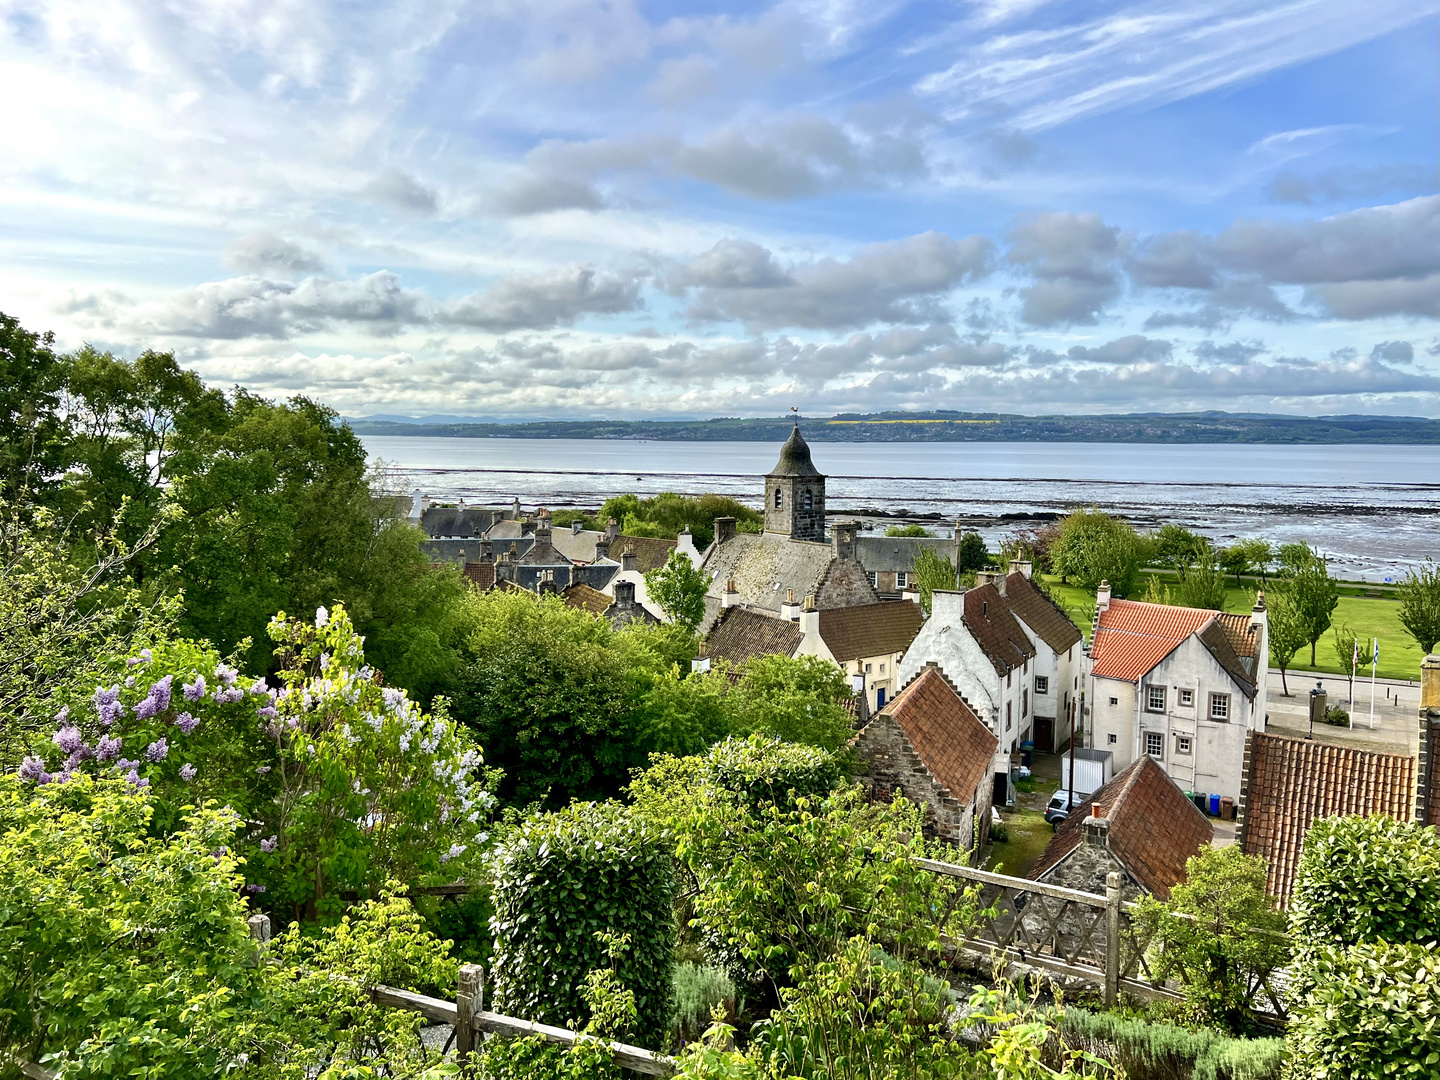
871;665;999;805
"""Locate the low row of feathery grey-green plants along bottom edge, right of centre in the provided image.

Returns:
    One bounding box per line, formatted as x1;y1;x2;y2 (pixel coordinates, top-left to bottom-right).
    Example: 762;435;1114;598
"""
1060;1008;1284;1080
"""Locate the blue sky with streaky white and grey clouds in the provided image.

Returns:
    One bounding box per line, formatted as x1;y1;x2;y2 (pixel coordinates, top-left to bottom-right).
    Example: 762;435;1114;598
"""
0;0;1440;418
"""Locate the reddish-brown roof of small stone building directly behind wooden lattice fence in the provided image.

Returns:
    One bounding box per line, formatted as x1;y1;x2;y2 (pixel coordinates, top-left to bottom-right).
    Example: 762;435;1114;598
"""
1028;756;1214;900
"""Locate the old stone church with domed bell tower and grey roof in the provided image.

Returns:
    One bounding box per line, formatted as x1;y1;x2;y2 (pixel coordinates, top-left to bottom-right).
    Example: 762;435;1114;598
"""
701;425;880;631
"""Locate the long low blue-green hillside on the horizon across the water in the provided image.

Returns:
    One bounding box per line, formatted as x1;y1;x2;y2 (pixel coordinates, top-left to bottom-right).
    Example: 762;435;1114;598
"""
348;410;1440;446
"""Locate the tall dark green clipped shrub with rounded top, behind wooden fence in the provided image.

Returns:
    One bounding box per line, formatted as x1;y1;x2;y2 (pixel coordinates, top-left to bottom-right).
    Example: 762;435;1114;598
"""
490;804;675;1045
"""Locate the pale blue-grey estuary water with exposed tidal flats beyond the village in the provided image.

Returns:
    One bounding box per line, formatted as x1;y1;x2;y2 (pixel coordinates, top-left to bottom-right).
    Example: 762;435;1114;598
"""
363;435;1440;580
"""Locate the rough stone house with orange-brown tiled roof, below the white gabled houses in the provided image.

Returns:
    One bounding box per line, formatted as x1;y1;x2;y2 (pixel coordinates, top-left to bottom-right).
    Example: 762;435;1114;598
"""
854;667;998;852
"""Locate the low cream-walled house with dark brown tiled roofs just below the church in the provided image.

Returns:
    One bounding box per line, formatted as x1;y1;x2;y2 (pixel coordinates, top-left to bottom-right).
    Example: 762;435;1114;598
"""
703;592;924;714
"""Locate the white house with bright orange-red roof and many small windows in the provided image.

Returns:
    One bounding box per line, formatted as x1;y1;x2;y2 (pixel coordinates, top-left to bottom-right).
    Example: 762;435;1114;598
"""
1086;582;1269;799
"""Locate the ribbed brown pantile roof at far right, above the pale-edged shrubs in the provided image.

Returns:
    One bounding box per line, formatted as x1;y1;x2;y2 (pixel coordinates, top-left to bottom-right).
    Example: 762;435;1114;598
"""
1240;732;1416;907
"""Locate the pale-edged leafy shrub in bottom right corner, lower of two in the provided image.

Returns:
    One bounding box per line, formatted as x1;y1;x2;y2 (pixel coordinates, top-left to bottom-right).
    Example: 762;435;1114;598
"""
1289;943;1440;1080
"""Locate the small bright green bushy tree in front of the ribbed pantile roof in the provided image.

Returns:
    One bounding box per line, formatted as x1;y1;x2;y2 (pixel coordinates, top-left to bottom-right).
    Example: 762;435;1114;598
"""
1140;845;1290;1034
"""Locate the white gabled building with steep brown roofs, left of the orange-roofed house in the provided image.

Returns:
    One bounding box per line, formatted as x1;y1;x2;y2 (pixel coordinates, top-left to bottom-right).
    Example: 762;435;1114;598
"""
900;560;1084;754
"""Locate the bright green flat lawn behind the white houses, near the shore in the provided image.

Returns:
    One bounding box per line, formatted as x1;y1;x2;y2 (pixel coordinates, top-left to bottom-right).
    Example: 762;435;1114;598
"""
1045;575;1423;680
